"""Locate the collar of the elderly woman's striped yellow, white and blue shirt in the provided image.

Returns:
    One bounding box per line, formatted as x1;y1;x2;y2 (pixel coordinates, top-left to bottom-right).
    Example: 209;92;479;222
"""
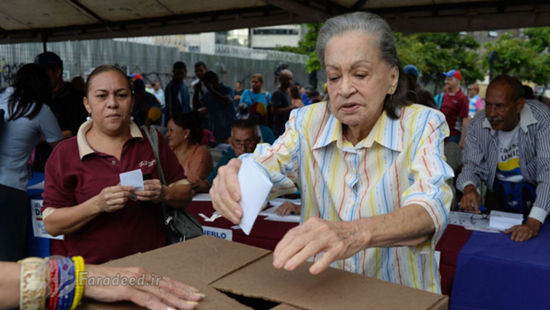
313;107;403;152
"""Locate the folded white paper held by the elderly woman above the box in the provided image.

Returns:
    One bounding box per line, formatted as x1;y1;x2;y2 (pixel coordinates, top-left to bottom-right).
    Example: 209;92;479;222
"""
238;158;273;235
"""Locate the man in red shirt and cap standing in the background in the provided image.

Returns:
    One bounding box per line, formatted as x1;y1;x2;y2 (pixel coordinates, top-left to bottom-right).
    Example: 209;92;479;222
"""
440;70;469;145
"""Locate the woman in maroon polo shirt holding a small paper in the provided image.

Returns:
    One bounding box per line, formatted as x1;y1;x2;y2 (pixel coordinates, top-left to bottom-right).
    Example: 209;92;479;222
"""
42;65;192;263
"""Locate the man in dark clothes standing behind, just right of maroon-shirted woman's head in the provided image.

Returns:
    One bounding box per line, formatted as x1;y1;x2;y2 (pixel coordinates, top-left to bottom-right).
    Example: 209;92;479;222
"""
164;61;191;127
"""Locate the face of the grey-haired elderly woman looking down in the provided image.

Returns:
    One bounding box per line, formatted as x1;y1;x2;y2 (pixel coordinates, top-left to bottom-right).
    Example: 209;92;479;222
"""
325;31;399;131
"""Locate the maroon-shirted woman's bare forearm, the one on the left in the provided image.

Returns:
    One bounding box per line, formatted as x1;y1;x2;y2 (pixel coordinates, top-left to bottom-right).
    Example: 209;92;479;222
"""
44;196;101;236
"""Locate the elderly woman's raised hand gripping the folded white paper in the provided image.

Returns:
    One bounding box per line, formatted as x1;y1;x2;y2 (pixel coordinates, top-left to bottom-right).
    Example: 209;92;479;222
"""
210;159;243;224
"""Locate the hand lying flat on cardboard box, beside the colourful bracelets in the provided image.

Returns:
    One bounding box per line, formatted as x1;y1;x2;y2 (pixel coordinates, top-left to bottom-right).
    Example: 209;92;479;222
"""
84;265;204;310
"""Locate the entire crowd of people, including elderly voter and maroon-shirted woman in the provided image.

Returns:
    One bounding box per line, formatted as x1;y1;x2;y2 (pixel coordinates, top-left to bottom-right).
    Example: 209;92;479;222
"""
0;8;550;308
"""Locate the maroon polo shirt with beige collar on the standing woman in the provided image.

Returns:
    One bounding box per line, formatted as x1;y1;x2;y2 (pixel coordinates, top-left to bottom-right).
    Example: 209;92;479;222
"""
42;122;185;264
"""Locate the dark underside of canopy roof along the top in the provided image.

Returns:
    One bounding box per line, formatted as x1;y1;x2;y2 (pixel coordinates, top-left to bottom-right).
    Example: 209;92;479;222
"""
0;0;550;44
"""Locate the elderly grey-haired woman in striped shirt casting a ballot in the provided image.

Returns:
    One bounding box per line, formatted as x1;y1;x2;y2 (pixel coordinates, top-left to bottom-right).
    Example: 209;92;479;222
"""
210;12;453;293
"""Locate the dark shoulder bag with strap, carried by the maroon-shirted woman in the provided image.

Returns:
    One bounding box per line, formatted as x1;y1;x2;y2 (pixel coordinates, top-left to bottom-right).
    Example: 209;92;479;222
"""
142;127;203;244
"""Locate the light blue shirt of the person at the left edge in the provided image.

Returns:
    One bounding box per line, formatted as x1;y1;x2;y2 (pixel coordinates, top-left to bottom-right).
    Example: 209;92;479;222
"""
0;87;63;191
